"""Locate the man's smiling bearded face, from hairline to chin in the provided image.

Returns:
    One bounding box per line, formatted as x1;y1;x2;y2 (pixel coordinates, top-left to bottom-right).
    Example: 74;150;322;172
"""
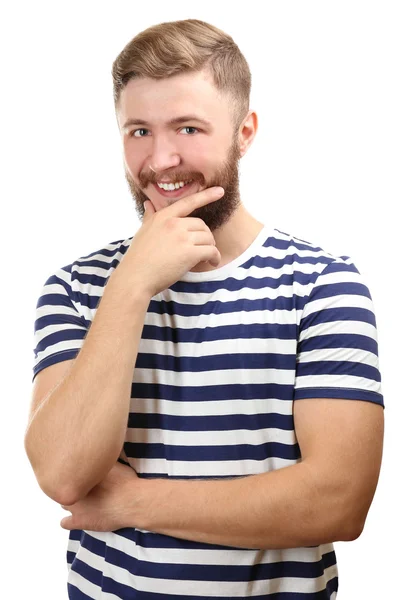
117;73;250;231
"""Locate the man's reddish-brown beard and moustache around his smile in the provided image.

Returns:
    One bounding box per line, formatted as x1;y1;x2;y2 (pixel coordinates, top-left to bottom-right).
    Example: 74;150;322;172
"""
125;137;241;231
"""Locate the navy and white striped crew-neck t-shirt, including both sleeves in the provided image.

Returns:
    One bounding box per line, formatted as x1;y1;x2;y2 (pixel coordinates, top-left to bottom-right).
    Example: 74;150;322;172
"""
33;226;383;600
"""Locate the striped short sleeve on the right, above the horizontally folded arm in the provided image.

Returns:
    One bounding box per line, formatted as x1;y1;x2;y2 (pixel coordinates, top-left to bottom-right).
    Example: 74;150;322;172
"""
294;257;384;406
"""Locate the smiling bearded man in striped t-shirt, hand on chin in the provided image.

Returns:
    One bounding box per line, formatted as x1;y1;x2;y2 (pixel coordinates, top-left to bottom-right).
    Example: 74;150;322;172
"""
25;19;383;600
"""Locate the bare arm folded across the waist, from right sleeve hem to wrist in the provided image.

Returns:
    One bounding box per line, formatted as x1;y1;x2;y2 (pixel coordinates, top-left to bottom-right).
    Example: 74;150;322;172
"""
130;398;384;548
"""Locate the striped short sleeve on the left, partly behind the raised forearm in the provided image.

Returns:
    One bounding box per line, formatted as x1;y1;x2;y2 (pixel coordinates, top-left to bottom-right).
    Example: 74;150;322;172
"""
32;265;90;381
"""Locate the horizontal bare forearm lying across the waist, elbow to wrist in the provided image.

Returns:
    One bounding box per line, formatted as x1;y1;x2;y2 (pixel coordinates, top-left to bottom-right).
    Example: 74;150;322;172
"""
132;463;349;548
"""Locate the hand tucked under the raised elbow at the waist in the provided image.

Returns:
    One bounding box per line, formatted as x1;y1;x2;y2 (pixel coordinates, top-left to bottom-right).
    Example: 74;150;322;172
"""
60;462;141;531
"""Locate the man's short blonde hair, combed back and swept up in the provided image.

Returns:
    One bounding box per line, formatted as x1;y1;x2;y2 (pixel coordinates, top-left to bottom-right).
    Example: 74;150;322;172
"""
112;19;251;133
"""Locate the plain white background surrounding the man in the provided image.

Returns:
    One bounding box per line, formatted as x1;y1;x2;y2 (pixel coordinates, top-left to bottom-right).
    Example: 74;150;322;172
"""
0;0;400;600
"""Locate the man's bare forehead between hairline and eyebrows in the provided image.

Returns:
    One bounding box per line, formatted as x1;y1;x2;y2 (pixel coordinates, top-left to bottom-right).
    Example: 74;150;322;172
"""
118;72;229;127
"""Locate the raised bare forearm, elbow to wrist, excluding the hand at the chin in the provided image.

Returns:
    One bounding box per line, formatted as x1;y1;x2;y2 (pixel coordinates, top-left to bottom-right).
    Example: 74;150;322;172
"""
26;273;149;504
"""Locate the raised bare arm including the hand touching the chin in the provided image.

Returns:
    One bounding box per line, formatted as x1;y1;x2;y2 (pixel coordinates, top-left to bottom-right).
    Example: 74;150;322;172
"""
25;187;224;506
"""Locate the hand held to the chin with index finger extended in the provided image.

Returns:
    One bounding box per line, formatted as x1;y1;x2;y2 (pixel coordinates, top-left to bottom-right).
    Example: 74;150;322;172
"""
108;187;224;298
